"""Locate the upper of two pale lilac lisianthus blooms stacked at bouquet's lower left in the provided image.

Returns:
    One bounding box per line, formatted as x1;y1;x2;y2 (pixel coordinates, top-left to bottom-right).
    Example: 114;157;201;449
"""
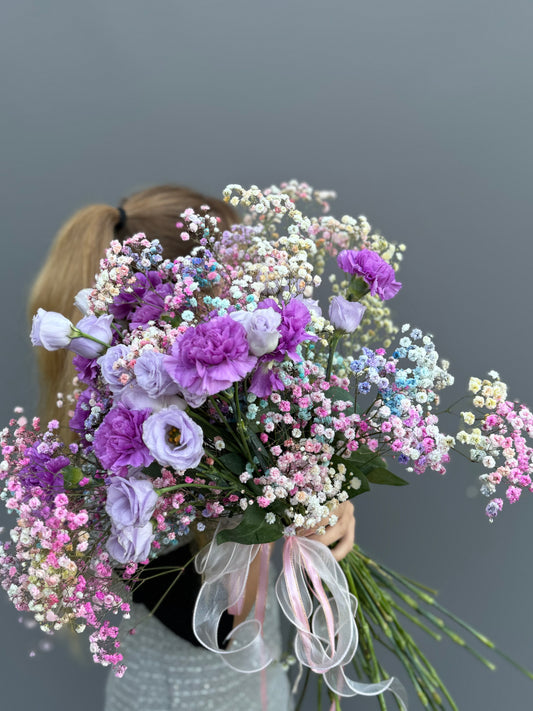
105;476;158;529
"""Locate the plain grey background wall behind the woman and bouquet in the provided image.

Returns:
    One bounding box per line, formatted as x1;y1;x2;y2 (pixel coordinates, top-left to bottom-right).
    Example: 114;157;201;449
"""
0;0;533;711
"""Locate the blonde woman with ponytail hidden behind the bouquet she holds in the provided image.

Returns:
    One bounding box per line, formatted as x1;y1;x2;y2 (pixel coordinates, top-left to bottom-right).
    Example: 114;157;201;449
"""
29;185;355;711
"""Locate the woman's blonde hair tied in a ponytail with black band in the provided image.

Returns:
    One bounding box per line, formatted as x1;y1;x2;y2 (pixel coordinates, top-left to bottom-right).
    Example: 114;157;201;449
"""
28;185;238;428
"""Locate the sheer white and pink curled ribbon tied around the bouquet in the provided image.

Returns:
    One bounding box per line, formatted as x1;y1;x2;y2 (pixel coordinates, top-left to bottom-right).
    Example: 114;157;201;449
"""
193;536;407;711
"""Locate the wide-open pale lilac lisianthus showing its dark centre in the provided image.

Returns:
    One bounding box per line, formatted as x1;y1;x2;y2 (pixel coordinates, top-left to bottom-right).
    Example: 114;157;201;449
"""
143;406;204;471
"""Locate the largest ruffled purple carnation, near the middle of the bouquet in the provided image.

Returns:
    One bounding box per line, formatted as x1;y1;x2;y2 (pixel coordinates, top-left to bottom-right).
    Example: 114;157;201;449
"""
165;316;257;395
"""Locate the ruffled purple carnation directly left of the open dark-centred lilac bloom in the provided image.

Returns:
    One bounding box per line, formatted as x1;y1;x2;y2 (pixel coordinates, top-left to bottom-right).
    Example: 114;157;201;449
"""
93;403;153;474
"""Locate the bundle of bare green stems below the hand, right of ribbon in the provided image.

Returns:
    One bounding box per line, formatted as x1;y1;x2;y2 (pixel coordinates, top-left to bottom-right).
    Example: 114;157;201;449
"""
328;545;533;711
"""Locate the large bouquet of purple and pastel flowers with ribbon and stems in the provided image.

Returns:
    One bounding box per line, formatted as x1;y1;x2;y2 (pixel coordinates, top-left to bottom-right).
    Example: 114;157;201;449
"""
0;181;533;709
